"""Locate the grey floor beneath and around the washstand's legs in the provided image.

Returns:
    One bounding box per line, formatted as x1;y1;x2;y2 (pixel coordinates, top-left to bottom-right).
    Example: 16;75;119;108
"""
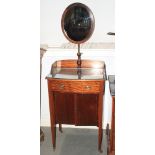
40;127;107;155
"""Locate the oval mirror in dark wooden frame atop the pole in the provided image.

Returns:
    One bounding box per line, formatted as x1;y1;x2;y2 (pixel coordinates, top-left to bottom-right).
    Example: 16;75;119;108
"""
61;3;95;44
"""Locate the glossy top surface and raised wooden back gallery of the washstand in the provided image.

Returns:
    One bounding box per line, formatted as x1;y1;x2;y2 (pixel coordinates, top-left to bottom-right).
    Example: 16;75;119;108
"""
46;60;106;80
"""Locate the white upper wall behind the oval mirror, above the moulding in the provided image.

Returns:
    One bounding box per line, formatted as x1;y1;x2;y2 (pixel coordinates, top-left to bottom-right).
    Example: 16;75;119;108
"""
40;0;115;46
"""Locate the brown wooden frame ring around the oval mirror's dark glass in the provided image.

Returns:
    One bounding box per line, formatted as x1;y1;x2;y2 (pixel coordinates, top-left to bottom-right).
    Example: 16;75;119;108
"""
61;3;95;44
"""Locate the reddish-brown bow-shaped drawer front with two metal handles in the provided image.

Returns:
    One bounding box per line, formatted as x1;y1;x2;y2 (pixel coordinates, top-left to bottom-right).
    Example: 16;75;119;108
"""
48;79;102;93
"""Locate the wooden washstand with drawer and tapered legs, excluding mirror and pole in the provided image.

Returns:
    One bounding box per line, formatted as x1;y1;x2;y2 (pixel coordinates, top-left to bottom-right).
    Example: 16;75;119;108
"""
46;60;106;151
